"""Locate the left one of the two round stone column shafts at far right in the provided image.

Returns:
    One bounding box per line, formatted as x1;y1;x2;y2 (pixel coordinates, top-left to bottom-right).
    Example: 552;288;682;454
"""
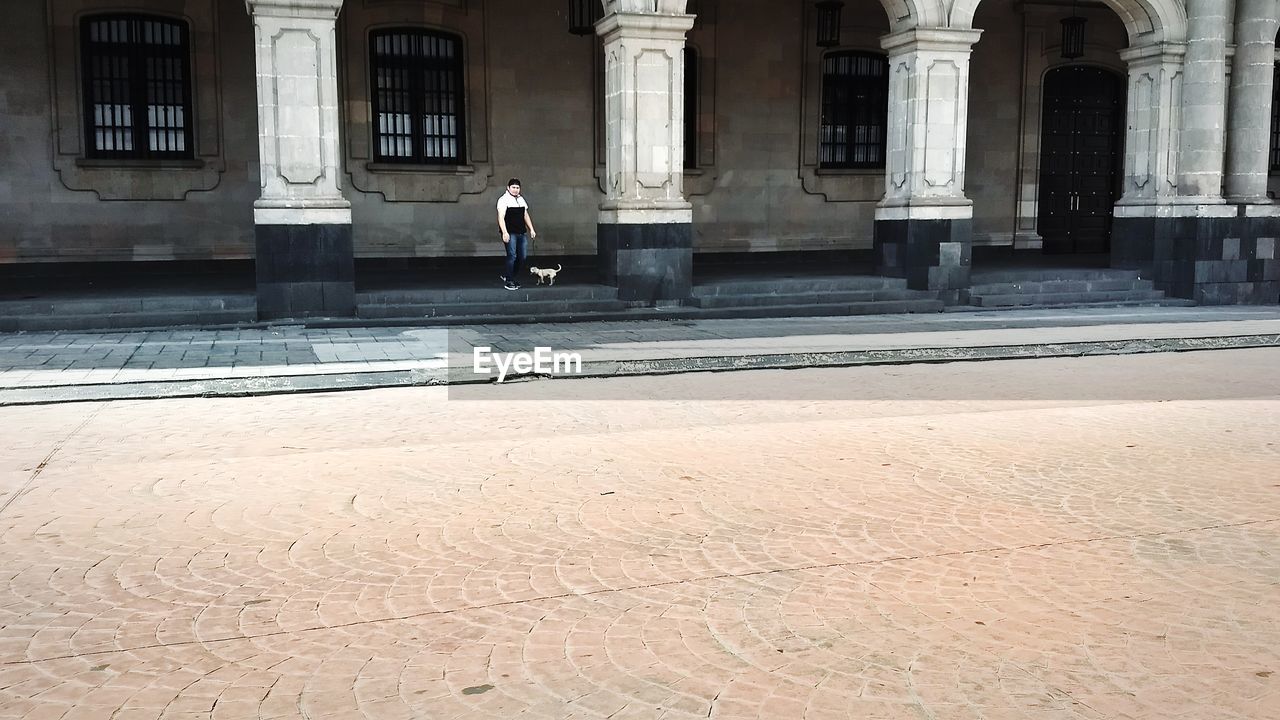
1178;0;1228;197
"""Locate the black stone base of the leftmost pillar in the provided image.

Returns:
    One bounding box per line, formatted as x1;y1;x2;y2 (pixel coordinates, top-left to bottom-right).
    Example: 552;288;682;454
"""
253;225;356;320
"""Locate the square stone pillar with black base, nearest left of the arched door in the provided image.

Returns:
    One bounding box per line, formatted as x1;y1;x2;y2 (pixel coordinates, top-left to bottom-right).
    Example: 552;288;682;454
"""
876;28;982;302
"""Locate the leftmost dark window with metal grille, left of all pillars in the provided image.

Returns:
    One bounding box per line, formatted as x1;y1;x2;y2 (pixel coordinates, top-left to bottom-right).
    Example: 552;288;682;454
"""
81;14;193;159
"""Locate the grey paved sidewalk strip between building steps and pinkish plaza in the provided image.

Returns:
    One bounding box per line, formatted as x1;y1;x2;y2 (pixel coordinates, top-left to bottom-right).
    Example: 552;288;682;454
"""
0;307;1280;405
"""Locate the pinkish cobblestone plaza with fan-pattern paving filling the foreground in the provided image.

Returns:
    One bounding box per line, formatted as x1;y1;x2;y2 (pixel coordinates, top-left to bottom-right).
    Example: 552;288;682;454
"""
0;348;1280;720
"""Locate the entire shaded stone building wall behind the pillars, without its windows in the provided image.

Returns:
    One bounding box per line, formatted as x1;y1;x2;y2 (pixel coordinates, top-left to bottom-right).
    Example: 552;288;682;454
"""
0;0;1172;263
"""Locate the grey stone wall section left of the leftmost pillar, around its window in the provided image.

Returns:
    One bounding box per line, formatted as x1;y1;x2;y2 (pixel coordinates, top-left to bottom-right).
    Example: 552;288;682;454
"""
0;0;257;263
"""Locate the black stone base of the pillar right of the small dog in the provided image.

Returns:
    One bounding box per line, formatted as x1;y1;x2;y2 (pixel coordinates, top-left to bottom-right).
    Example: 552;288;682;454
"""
595;223;694;302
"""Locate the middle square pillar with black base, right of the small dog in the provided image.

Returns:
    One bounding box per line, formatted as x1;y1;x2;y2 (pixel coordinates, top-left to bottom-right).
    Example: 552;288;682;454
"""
595;0;694;304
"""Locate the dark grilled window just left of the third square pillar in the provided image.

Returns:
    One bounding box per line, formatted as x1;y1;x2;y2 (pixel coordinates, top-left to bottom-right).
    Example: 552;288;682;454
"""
818;53;888;168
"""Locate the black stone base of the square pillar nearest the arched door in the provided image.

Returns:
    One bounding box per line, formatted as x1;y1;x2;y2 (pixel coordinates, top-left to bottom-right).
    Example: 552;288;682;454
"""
874;213;973;305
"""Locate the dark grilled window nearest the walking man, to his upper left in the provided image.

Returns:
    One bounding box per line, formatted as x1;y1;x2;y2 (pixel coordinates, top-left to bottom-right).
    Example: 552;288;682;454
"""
370;28;466;165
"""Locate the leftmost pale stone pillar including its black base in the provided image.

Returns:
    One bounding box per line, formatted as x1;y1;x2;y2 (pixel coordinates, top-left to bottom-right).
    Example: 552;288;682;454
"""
244;0;355;319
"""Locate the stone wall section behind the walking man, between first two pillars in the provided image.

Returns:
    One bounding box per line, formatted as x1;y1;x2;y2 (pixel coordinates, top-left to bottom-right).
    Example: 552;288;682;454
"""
339;0;603;256
